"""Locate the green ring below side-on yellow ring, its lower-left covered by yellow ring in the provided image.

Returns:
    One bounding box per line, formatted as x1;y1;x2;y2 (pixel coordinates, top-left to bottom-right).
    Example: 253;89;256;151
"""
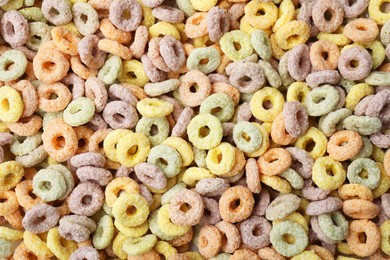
135;116;169;146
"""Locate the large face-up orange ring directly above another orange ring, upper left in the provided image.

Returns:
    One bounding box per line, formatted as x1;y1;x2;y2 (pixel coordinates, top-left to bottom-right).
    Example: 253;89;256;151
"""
33;42;69;84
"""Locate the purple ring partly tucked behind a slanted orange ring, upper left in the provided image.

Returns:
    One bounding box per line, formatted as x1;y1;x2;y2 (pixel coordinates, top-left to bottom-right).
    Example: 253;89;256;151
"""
77;35;107;70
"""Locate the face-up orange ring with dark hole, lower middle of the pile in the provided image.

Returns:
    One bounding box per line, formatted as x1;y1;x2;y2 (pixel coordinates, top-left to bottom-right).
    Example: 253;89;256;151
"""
219;186;255;223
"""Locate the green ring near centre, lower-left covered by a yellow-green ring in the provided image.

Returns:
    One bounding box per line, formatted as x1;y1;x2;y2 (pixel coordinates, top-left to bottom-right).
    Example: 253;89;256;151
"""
199;93;234;122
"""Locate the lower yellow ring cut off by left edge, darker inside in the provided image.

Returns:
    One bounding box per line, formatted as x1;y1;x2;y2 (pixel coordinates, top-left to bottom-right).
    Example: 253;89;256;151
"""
0;161;24;191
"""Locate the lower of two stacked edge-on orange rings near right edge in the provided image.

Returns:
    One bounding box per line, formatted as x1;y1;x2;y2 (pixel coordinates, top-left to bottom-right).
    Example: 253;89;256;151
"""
342;199;380;219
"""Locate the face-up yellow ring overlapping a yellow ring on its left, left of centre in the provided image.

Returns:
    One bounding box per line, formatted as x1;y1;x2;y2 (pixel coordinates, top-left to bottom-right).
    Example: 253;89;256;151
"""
116;133;150;167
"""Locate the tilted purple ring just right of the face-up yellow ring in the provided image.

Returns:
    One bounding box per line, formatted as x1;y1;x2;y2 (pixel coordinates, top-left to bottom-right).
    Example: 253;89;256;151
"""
283;101;309;138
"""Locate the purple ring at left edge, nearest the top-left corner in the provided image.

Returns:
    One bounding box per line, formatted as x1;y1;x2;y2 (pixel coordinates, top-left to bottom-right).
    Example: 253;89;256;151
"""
1;10;30;47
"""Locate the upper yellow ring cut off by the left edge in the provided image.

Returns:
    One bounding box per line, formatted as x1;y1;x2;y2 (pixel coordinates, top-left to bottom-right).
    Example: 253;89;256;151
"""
0;86;24;123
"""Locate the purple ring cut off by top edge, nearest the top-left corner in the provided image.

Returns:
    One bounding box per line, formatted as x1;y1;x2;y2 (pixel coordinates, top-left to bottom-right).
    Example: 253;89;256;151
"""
41;0;72;26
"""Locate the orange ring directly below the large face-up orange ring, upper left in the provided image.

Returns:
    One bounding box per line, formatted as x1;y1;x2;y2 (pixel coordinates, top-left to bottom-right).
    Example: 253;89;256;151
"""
37;82;72;112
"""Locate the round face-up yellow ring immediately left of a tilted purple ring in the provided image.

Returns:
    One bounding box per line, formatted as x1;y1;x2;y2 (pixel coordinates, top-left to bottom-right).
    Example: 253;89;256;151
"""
250;87;284;122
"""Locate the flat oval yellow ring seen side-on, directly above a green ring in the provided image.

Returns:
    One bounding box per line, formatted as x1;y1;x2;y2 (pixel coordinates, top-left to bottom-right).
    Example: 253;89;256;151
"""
137;98;173;117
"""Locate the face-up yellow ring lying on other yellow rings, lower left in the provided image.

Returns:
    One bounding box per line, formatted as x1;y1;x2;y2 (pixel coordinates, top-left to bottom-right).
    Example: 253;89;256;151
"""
112;193;149;227
